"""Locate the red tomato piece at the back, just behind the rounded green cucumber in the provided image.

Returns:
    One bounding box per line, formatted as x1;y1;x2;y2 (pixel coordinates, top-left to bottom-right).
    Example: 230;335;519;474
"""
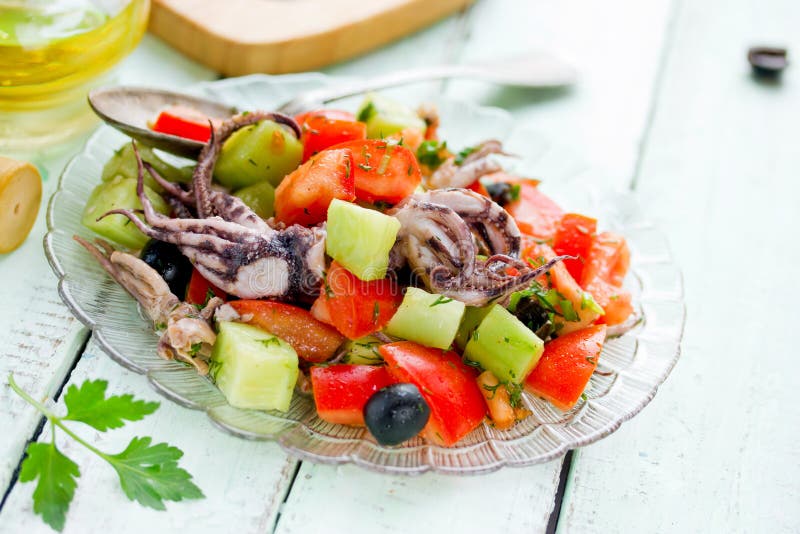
295;109;367;162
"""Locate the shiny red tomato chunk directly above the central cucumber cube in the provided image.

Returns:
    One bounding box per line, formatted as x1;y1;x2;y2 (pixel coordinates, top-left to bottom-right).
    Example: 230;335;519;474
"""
333;139;422;204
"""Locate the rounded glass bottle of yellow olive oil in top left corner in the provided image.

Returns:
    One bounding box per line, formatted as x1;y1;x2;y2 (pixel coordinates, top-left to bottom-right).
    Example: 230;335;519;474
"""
0;0;150;150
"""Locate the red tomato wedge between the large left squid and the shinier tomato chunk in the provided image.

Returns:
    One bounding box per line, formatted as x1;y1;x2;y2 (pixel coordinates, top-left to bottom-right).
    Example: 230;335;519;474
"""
275;149;356;226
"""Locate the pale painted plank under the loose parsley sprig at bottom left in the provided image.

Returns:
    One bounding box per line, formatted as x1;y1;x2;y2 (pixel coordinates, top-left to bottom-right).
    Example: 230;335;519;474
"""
0;342;296;534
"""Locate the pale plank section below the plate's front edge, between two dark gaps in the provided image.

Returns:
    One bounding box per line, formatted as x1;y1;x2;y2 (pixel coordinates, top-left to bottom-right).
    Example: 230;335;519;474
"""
275;461;561;534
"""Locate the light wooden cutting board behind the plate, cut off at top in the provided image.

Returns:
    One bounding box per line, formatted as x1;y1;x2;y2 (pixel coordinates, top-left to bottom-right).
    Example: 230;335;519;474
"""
150;0;473;76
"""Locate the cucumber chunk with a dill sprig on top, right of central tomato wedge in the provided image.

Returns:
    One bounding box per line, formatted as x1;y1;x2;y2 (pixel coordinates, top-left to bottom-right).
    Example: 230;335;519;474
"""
384;287;466;349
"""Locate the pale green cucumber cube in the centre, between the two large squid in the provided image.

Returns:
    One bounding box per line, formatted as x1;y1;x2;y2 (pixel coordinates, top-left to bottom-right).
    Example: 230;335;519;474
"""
325;199;400;280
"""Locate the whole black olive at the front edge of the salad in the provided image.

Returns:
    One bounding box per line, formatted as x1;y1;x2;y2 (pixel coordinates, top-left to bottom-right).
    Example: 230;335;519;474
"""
364;384;431;445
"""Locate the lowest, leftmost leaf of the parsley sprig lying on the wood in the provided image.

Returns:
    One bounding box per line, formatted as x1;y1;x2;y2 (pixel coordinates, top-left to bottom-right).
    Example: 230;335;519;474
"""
19;443;80;532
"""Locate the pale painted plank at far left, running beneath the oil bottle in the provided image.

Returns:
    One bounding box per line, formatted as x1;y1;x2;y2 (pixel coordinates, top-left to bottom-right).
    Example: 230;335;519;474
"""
0;36;215;500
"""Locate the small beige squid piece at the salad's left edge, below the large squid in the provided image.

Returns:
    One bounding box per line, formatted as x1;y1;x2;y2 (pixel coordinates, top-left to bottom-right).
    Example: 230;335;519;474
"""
74;236;217;375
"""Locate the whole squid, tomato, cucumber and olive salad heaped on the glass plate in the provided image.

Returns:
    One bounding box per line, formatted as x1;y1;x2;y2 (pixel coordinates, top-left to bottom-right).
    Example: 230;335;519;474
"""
75;94;634;446
